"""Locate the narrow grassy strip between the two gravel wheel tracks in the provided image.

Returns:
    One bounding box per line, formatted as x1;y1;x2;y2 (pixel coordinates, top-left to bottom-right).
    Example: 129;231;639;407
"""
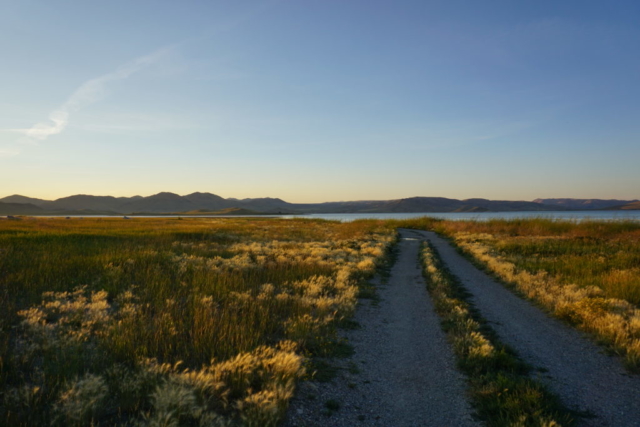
421;245;574;426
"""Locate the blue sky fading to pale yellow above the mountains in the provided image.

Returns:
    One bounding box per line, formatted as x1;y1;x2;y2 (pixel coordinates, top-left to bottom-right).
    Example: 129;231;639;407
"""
0;0;640;203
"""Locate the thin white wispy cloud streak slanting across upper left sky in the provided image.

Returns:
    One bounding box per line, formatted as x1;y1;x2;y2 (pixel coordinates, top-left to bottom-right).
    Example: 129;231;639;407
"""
18;45;173;142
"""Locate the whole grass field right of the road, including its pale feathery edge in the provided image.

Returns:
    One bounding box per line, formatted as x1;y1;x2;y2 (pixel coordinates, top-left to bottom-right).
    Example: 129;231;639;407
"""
414;219;640;372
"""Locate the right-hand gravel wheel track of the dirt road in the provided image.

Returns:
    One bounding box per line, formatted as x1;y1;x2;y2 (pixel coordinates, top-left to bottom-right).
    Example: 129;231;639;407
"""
412;231;640;427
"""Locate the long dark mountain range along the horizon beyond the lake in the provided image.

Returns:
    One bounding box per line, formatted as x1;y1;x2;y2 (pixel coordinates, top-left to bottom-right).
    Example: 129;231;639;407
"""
0;192;640;215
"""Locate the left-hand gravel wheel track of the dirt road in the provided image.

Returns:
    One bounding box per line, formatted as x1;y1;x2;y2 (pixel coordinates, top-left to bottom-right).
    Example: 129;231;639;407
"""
284;231;477;427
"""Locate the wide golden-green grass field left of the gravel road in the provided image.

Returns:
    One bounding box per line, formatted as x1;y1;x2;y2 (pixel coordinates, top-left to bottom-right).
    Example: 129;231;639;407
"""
0;218;395;426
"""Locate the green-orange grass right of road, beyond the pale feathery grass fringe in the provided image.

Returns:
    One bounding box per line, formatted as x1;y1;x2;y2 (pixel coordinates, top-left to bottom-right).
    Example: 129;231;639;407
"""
439;219;640;305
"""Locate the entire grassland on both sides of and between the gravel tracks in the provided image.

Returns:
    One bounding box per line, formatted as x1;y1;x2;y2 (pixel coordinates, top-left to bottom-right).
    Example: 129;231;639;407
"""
0;218;640;426
